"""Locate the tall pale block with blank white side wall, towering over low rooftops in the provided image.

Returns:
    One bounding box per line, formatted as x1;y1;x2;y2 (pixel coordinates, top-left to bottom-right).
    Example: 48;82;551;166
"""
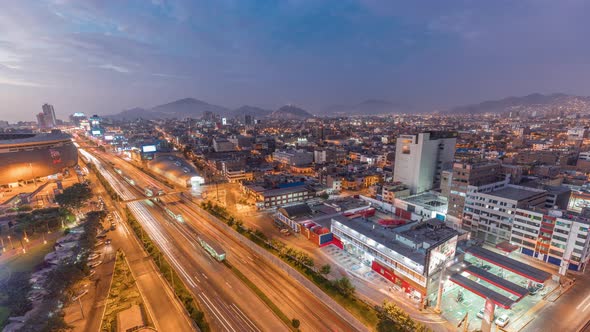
393;131;457;194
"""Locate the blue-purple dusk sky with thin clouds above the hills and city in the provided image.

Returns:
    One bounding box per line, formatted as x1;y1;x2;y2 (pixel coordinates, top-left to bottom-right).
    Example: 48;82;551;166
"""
0;0;590;121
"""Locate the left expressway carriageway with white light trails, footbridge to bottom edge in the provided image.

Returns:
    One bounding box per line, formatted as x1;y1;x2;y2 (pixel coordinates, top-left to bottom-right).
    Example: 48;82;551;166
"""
128;202;286;331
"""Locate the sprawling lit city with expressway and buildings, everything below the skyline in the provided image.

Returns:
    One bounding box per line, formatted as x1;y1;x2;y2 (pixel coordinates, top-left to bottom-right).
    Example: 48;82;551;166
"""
0;94;590;331
